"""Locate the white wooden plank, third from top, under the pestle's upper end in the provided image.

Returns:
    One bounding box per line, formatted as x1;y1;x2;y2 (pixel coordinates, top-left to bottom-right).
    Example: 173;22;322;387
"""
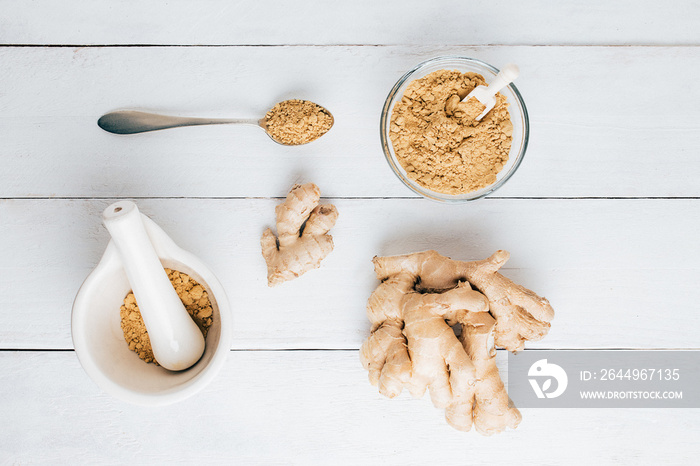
0;198;700;349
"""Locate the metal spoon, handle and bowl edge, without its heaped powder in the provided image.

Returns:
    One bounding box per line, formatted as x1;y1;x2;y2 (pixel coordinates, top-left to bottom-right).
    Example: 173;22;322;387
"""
97;101;334;145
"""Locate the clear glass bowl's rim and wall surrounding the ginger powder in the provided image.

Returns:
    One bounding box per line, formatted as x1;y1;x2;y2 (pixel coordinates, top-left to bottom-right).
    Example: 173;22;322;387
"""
380;56;530;203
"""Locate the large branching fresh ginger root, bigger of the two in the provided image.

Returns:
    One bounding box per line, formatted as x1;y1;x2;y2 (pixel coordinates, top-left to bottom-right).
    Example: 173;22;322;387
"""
360;251;554;435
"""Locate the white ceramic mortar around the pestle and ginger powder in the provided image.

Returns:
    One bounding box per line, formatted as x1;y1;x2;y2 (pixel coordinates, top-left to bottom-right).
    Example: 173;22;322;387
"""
71;209;232;406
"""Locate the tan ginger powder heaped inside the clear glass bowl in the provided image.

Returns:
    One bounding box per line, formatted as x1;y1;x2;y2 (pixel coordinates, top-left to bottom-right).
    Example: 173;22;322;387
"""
389;70;513;195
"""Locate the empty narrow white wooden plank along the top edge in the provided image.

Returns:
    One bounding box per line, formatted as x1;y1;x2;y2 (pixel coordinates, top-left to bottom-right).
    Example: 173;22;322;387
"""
0;0;700;45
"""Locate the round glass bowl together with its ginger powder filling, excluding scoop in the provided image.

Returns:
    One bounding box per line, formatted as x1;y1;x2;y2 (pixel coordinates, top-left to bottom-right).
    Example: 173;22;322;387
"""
380;57;529;202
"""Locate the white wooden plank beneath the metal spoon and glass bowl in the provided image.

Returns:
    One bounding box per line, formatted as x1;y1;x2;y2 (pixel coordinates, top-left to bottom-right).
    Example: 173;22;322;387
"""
0;47;700;197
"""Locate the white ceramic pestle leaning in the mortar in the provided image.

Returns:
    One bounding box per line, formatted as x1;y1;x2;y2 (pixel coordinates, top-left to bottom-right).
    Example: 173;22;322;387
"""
102;201;204;371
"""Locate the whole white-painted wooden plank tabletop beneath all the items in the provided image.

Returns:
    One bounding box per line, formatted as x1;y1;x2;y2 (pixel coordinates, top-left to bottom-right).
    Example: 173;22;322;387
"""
0;0;700;464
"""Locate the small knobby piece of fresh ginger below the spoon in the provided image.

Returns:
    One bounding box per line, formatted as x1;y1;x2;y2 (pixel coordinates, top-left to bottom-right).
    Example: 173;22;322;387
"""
260;183;338;286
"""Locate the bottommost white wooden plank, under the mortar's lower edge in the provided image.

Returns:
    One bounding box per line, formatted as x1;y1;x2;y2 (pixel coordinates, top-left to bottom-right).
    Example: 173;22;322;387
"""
0;351;700;465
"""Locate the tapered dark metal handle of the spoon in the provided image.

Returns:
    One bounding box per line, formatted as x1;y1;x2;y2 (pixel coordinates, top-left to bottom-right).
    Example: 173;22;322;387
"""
97;110;259;134
